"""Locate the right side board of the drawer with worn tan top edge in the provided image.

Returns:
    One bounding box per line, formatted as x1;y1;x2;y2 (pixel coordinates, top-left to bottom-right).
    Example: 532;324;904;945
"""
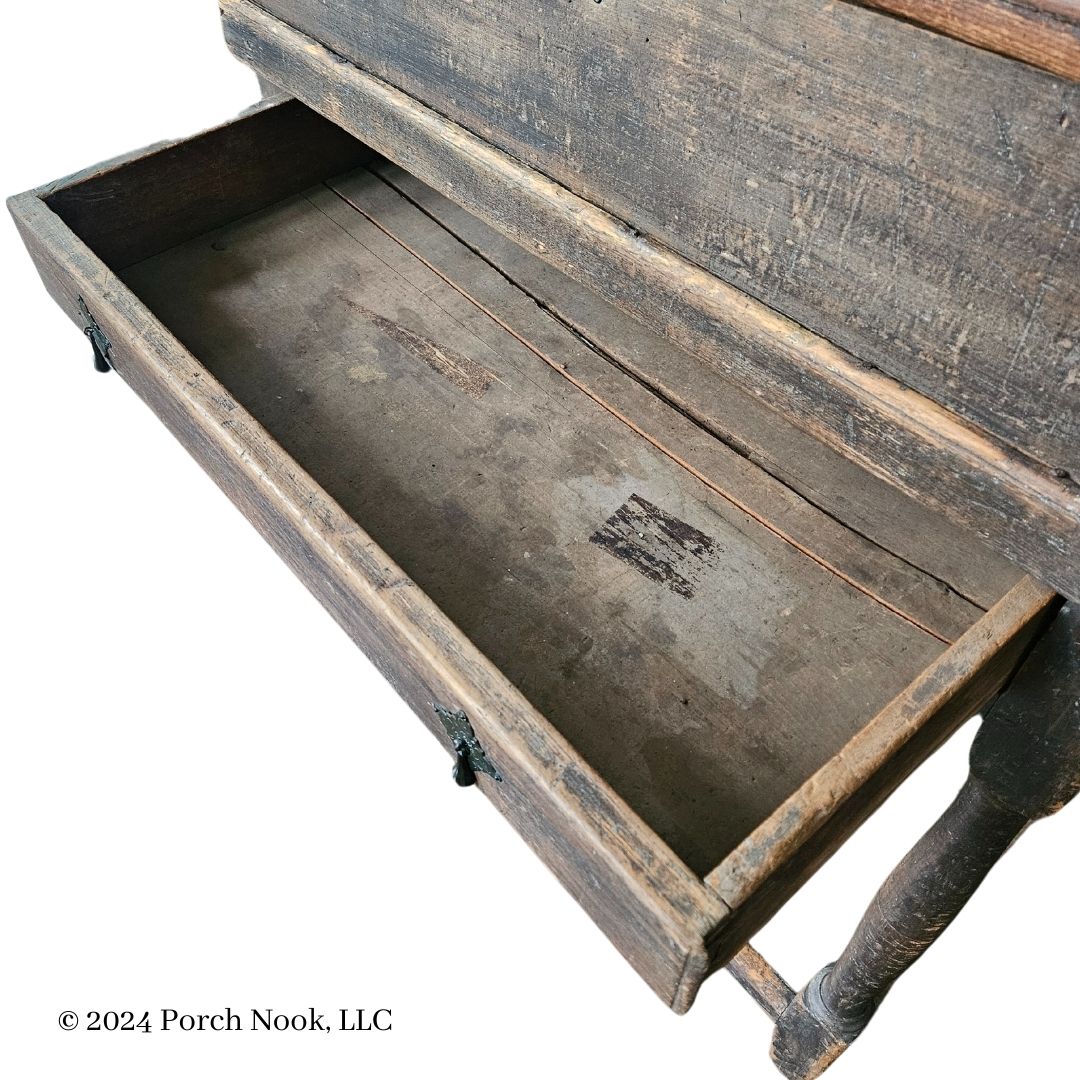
705;578;1059;967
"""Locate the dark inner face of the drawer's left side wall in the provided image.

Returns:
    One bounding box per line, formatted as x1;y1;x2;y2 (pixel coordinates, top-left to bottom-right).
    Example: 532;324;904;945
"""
43;100;370;269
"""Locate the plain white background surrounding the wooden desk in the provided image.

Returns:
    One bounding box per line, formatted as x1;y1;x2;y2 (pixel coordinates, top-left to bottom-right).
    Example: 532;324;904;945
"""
0;0;1080;1080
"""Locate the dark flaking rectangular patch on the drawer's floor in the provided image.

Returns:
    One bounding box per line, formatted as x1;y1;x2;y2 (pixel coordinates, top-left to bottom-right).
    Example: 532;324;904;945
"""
589;495;719;599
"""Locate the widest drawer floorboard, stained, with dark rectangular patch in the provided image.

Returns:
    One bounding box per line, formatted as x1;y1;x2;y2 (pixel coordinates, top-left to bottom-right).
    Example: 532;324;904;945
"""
124;181;943;874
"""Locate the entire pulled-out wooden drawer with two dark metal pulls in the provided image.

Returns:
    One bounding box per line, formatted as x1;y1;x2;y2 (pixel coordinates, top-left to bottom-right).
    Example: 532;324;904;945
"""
10;102;1055;1011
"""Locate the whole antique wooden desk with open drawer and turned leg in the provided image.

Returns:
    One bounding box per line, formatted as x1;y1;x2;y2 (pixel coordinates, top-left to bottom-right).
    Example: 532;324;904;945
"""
10;0;1080;1077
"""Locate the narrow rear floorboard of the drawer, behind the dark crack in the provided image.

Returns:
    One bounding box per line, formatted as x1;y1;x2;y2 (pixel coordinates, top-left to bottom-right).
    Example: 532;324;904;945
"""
369;159;1023;629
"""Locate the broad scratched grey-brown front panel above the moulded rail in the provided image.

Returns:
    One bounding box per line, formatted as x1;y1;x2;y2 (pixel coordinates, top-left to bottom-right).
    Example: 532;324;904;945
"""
254;0;1080;473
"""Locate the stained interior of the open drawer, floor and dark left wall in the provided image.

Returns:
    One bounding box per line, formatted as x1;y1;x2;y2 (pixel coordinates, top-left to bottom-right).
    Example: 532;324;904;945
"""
31;104;1021;877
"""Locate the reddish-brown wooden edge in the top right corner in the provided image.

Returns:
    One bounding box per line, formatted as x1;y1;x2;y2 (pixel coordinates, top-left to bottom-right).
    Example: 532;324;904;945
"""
854;0;1080;80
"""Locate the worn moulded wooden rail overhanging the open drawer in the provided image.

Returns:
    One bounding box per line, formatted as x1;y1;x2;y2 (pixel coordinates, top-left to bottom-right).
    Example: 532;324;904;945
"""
222;0;1080;595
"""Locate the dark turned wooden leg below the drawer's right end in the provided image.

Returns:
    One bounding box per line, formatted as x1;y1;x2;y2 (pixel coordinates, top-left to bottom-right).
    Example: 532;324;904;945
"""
772;604;1080;1080
